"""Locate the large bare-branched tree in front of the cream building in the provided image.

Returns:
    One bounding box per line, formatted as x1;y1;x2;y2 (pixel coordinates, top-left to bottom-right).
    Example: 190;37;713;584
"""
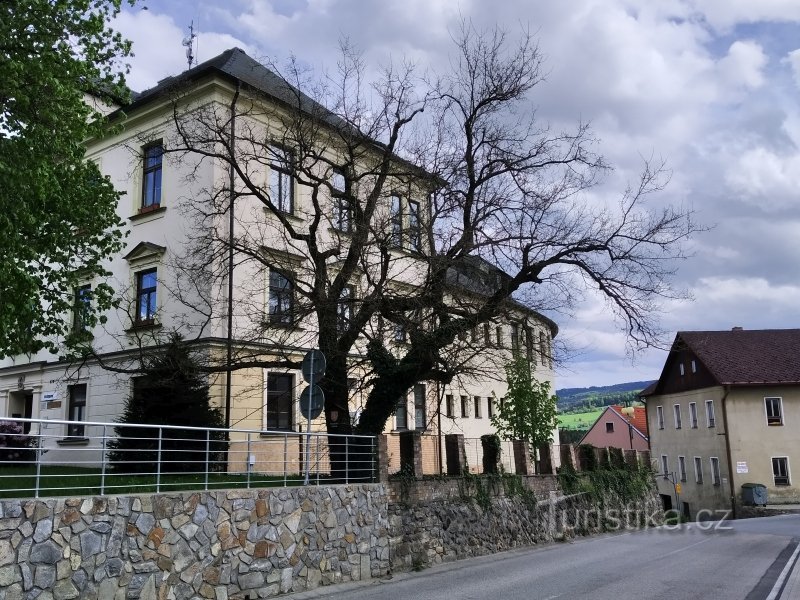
95;23;697;454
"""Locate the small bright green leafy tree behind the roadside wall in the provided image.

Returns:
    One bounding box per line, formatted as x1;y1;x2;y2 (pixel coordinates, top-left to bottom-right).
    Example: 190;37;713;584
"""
492;354;556;448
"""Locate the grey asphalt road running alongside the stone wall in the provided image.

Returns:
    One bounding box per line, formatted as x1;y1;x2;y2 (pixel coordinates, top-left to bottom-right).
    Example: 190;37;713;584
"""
286;515;800;600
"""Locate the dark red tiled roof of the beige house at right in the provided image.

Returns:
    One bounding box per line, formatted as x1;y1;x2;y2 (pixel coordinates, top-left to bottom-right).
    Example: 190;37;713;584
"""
673;329;800;385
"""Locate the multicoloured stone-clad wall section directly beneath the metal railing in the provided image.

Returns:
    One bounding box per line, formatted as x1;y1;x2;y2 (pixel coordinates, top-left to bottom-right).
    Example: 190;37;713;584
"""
0;484;389;600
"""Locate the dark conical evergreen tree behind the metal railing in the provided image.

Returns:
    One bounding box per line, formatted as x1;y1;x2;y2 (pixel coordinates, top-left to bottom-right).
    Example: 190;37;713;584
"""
108;335;225;473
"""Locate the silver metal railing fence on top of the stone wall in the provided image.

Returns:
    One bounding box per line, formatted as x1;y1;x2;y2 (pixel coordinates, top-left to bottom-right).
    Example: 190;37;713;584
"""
0;418;376;498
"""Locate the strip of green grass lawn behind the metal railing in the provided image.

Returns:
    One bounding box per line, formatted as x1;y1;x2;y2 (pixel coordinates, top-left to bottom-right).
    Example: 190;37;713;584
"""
0;465;304;498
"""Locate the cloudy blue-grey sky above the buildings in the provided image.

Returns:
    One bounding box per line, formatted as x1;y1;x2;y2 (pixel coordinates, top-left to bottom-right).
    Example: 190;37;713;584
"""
114;0;800;388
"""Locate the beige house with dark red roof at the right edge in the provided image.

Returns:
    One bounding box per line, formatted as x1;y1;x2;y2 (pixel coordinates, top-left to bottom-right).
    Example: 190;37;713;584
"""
641;327;800;519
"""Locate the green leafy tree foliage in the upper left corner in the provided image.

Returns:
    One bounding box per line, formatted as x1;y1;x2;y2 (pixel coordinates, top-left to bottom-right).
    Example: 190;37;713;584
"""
0;0;132;358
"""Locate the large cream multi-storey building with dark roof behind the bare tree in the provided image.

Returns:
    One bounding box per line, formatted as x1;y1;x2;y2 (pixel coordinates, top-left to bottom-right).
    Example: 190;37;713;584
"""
0;49;557;470
